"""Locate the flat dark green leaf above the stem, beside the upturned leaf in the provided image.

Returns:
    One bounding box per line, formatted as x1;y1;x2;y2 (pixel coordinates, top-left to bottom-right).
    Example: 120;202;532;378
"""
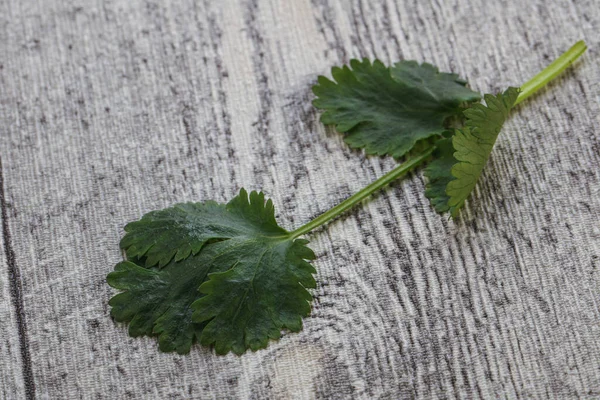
313;59;481;158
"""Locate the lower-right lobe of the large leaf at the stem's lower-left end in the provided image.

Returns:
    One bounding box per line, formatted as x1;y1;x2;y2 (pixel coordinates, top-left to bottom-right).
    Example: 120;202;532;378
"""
192;238;315;354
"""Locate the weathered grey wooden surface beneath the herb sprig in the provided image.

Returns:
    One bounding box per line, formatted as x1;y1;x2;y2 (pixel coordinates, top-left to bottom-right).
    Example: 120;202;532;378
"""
0;0;600;399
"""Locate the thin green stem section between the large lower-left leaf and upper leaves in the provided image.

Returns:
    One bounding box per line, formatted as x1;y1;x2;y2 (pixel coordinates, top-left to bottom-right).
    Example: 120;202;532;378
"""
291;147;434;239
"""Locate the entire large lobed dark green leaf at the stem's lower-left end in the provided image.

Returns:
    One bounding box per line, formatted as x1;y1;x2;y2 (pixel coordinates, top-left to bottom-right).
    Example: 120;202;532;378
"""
107;189;315;354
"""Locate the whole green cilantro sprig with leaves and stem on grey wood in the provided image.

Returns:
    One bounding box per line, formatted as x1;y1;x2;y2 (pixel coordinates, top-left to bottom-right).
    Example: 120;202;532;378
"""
107;42;586;354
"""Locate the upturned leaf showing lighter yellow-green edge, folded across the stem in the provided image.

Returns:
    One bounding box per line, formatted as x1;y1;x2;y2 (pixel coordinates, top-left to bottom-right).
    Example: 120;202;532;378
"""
425;87;519;217
